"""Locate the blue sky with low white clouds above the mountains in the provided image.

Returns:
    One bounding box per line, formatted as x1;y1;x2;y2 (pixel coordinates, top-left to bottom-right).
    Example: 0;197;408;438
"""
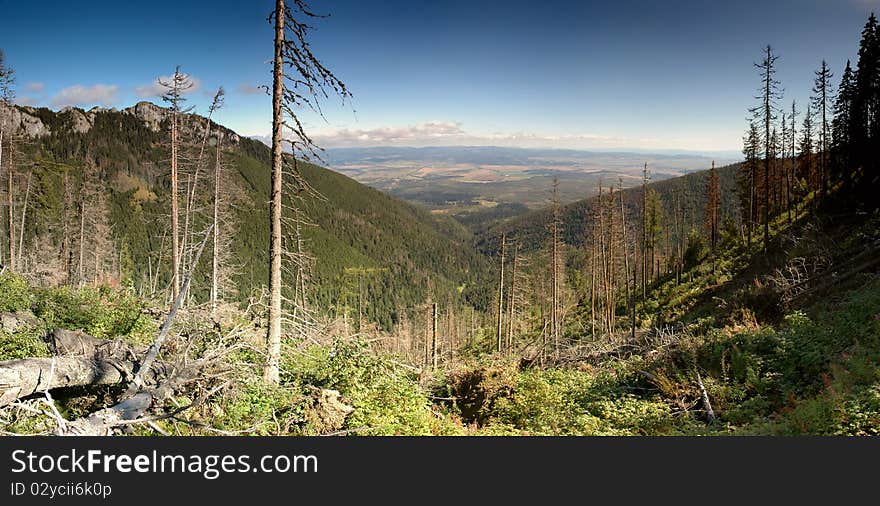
0;0;880;152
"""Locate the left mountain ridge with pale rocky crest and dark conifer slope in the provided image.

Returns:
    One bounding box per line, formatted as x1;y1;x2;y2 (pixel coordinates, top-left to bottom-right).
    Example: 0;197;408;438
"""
0;102;496;328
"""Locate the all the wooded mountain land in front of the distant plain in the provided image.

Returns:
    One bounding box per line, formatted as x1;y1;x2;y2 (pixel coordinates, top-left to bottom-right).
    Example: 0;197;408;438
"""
0;2;880;436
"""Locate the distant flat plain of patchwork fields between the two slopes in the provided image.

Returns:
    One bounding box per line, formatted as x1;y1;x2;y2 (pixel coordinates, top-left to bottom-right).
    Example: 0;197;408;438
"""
326;147;732;229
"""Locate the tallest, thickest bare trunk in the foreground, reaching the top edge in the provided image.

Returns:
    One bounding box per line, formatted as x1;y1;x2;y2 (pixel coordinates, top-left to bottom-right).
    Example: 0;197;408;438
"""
263;0;286;384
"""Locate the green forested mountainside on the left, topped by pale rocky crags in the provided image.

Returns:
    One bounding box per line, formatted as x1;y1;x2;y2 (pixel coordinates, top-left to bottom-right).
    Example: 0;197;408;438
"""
0;102;487;328
